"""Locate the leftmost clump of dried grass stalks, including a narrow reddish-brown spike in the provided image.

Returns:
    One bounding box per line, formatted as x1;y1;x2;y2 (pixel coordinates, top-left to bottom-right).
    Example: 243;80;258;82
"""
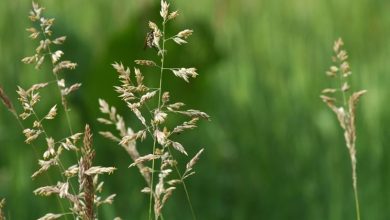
6;2;115;220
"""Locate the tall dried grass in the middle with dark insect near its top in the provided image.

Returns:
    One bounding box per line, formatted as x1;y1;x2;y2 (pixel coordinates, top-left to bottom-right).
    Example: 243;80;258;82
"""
98;0;210;220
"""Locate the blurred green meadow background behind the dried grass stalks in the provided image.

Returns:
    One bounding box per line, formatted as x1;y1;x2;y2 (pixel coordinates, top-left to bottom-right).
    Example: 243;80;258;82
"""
0;0;390;220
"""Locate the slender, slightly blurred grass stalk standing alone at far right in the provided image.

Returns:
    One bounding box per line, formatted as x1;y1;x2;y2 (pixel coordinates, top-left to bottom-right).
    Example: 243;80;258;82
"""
321;38;366;220
